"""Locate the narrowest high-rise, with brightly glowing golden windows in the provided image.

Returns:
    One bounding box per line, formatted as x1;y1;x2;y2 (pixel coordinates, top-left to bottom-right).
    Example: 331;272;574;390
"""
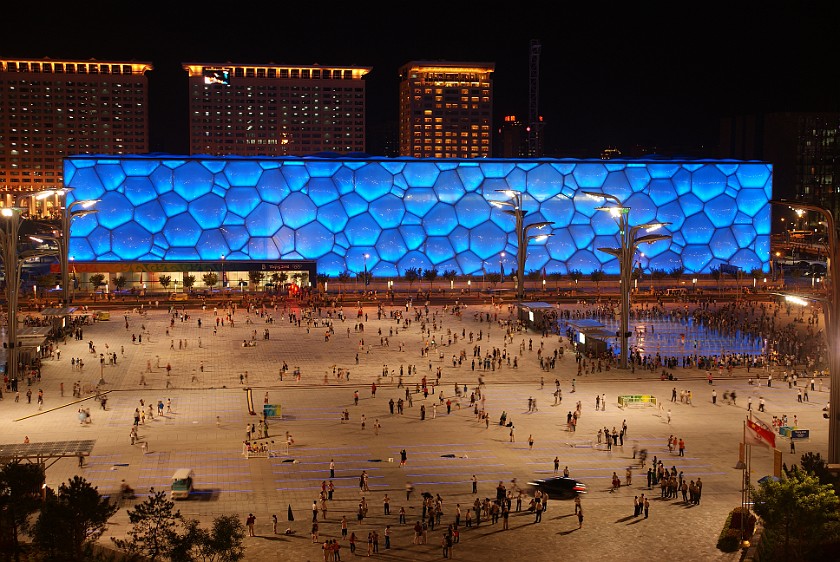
399;61;495;158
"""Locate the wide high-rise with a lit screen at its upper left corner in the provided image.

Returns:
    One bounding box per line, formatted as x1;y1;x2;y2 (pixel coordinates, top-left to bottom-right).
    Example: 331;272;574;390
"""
183;63;372;156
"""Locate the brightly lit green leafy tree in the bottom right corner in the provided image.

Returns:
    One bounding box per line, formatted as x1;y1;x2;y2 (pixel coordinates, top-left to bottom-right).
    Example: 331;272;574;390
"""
751;465;840;560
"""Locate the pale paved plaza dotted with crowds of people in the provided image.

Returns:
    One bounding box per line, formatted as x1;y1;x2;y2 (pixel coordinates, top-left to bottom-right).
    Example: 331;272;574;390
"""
0;301;829;561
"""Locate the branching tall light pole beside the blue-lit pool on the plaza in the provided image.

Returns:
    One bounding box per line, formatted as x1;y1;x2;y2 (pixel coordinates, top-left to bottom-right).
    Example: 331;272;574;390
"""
583;191;671;369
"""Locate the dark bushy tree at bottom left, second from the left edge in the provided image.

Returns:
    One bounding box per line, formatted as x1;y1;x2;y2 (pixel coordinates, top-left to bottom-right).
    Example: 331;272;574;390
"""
32;476;118;562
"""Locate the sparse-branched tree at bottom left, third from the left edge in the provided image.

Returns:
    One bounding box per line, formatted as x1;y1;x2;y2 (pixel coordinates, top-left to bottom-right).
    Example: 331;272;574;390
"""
111;488;184;560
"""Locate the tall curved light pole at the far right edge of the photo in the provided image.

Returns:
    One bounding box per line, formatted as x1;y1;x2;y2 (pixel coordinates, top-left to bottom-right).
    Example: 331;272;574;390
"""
770;199;840;464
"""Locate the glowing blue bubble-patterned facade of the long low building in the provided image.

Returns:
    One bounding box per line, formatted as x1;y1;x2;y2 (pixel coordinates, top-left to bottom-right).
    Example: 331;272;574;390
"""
64;156;772;276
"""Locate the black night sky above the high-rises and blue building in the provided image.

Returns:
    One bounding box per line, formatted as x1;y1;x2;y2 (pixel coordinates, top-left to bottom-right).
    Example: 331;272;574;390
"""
0;0;840;156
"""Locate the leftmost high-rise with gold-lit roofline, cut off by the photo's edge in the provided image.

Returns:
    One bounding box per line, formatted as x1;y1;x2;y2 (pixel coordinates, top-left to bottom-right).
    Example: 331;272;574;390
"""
0;59;152;214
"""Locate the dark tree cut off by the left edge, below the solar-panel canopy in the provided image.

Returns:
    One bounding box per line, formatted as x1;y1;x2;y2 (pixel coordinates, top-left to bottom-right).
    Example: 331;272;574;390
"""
0;461;44;554
